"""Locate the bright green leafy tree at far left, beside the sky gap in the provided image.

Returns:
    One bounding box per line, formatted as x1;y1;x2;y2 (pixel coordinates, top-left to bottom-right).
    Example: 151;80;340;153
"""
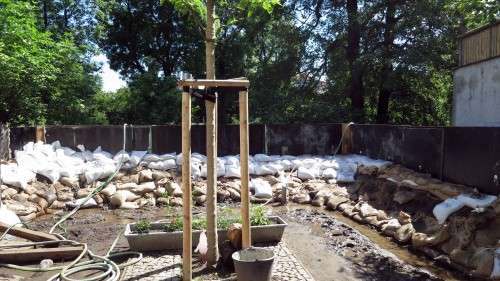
0;0;100;125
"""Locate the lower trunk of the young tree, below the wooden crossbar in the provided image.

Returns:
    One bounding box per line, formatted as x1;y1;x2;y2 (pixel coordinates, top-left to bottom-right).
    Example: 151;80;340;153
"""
205;98;219;266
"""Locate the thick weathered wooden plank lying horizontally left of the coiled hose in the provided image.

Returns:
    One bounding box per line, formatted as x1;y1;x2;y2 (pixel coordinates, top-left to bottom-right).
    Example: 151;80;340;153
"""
0;246;83;264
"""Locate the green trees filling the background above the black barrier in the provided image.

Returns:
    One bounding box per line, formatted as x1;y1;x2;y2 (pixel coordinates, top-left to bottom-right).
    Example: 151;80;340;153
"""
0;0;500;125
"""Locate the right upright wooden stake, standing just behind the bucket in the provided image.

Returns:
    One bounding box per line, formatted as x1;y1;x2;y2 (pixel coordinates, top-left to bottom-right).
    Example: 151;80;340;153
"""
239;91;252;249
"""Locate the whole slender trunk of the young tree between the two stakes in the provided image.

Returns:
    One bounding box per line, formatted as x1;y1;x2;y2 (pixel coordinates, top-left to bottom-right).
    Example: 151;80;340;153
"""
205;0;219;266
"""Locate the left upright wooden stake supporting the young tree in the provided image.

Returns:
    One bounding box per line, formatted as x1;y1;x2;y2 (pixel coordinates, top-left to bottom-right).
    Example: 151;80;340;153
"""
182;92;193;281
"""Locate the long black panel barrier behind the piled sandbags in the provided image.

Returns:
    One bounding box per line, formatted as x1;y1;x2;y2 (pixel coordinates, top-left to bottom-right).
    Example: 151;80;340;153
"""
10;124;500;194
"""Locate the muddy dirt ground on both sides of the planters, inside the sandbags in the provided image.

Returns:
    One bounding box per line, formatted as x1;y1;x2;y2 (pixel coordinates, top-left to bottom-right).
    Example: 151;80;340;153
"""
0;202;471;281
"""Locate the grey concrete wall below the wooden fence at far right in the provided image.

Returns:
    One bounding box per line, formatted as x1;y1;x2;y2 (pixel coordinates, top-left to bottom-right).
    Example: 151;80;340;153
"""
453;57;500;127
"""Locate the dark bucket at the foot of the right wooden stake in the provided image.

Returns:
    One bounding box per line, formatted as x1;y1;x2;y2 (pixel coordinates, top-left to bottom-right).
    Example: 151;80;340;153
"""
232;247;274;281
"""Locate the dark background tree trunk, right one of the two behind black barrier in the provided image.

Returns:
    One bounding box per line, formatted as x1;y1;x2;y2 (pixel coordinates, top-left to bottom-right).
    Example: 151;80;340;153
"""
377;0;397;123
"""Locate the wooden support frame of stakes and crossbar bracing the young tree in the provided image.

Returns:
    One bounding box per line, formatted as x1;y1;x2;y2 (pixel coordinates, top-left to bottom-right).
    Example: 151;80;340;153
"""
178;79;252;280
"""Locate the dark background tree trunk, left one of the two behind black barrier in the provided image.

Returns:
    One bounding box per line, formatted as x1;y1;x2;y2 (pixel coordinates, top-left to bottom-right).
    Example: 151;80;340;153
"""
346;0;365;122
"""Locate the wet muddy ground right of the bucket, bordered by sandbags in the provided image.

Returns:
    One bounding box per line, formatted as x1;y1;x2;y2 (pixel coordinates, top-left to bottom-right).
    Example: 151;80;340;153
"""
274;205;471;281
